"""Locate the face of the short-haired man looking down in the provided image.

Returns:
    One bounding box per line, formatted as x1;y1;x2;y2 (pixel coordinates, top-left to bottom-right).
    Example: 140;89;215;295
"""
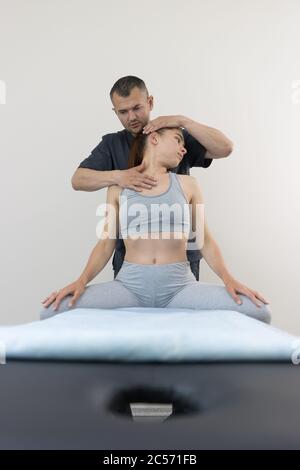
112;87;153;135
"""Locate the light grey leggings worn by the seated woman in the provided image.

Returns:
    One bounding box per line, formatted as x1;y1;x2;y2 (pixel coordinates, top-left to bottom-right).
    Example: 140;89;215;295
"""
40;261;271;323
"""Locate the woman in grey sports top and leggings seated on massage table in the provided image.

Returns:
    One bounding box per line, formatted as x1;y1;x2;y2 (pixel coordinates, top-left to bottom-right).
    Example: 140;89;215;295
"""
42;128;271;323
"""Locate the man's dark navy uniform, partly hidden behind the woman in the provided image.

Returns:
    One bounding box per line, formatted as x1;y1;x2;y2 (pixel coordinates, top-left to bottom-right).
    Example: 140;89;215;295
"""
78;129;212;281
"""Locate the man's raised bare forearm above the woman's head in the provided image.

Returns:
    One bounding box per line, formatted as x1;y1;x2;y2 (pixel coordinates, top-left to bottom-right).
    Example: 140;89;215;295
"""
181;116;233;158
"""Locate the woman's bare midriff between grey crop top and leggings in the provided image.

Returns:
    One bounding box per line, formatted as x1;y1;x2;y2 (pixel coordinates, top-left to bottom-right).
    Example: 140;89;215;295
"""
124;233;187;264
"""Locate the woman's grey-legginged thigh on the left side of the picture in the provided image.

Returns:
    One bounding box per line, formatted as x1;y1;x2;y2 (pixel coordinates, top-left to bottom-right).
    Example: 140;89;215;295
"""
40;281;141;320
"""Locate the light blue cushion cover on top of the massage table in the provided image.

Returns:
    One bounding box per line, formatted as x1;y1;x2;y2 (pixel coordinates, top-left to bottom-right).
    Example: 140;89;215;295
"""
0;307;300;362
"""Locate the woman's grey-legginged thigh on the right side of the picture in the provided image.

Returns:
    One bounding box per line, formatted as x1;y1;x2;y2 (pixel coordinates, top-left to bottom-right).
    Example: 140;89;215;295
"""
166;282;271;323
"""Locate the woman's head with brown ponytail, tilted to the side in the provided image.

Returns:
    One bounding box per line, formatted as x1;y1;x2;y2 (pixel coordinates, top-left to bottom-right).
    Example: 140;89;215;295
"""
128;127;186;170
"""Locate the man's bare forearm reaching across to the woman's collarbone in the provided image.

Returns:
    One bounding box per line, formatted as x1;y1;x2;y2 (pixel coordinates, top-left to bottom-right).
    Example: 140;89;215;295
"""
72;168;120;191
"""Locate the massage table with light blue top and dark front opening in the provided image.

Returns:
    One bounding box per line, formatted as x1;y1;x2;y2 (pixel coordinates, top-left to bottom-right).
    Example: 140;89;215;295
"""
0;307;300;450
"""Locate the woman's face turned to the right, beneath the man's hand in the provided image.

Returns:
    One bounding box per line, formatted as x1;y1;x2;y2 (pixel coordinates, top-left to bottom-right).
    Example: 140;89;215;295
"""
156;128;187;168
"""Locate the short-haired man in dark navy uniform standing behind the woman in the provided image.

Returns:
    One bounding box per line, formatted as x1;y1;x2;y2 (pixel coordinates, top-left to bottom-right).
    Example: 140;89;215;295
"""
72;76;233;280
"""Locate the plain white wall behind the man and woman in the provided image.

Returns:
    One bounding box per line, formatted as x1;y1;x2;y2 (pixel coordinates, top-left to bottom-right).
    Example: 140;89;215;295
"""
0;0;300;334
